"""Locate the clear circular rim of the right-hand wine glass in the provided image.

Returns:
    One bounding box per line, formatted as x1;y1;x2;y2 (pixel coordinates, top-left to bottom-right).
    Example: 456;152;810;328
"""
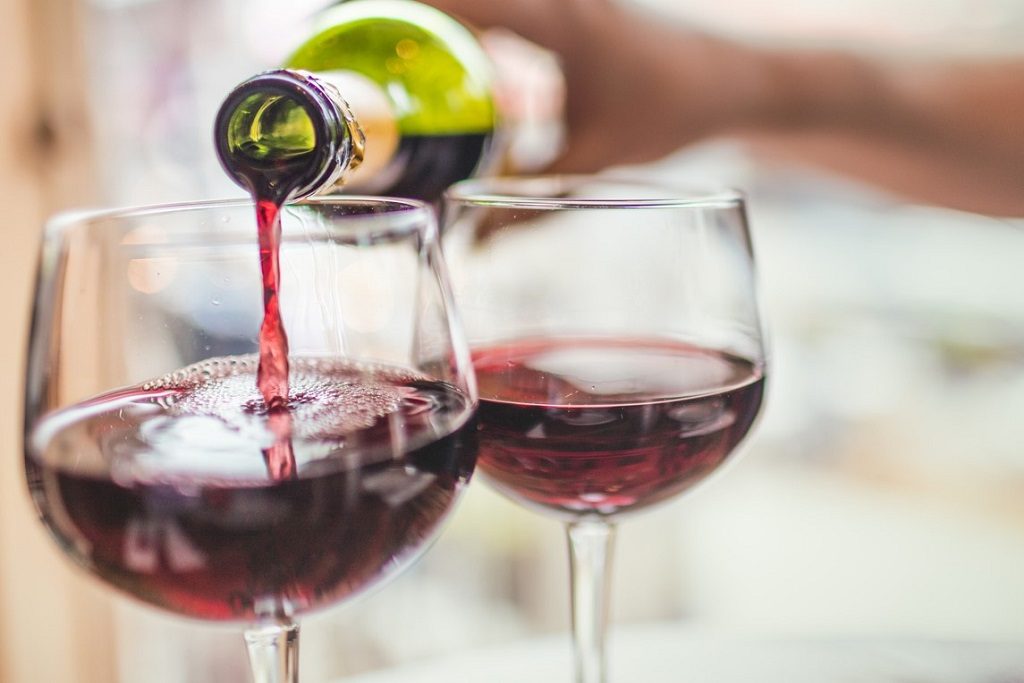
444;174;744;209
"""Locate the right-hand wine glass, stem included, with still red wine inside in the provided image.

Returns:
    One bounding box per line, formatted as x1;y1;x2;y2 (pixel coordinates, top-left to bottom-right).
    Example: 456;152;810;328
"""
442;176;766;683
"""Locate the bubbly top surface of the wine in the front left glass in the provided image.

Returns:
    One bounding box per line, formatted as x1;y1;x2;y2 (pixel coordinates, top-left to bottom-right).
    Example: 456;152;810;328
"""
34;355;470;485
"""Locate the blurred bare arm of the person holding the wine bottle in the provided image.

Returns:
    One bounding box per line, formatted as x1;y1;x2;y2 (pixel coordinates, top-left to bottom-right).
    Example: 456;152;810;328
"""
426;0;1024;215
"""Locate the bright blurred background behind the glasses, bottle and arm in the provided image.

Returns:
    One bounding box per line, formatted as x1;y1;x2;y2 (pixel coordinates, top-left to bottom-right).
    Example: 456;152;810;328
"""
0;0;1024;683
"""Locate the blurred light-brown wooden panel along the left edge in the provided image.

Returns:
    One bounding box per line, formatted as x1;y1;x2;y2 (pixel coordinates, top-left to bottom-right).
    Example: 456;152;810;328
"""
0;0;116;683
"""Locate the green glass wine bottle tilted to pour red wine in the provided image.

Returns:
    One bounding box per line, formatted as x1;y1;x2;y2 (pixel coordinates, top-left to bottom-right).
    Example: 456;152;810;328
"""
214;0;497;203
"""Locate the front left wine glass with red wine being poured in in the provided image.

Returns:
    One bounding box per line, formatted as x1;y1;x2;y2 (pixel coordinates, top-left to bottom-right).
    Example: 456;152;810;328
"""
25;198;477;683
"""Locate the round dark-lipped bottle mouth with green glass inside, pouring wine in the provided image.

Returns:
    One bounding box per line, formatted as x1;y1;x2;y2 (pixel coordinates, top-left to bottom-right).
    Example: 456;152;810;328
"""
214;69;352;202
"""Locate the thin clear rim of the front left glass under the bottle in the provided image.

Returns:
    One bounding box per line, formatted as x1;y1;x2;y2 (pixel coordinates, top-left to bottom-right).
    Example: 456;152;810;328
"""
45;195;433;236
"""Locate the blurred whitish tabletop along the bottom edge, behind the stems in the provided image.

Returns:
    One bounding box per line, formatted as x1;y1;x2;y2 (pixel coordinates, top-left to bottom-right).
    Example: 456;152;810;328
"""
338;625;1024;683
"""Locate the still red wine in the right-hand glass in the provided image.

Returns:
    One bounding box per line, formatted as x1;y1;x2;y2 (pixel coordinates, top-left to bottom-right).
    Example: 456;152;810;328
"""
473;339;764;517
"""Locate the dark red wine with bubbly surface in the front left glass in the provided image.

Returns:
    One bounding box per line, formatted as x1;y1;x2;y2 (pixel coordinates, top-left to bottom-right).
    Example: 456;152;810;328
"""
27;356;476;621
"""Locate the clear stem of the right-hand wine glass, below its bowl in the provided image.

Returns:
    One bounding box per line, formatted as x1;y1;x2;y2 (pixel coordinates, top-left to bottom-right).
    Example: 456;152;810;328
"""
566;519;615;683
